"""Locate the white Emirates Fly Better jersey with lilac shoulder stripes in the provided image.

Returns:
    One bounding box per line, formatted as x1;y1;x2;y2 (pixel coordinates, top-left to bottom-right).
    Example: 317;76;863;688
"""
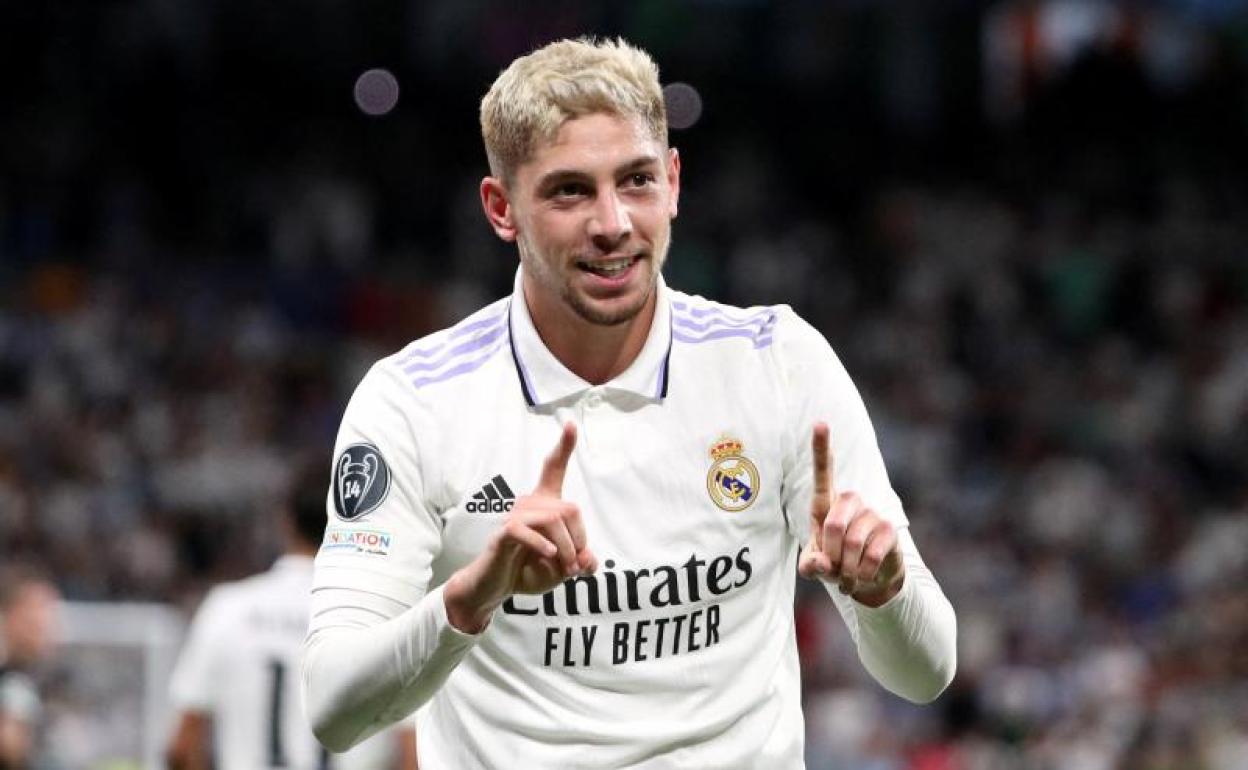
305;268;955;769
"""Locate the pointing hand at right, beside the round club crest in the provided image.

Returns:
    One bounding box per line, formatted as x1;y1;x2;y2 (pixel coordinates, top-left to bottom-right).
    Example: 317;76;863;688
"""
797;423;906;607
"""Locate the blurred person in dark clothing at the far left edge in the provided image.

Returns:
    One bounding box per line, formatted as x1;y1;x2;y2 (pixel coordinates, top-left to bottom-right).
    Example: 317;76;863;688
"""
0;564;61;770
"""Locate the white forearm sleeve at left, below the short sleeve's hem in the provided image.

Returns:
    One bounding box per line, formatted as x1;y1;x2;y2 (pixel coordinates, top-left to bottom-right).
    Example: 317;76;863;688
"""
303;579;475;751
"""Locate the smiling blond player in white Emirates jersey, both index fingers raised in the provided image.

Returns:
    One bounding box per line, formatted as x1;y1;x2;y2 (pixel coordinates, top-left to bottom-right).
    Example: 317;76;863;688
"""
303;40;955;768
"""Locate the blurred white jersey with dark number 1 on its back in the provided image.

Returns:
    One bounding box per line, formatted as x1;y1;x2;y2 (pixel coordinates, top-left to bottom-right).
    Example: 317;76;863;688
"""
170;555;398;770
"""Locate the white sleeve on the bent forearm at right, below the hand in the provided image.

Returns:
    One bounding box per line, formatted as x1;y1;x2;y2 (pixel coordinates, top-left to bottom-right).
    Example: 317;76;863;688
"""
829;530;957;703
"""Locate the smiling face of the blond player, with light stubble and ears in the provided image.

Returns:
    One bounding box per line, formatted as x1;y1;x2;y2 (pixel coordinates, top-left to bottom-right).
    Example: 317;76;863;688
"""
482;114;680;326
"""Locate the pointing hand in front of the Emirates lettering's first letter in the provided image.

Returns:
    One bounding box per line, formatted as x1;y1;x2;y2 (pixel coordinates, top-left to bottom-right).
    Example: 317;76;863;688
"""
443;423;598;633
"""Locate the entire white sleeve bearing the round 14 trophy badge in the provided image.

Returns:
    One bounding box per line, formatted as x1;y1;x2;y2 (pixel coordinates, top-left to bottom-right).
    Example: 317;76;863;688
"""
302;362;474;750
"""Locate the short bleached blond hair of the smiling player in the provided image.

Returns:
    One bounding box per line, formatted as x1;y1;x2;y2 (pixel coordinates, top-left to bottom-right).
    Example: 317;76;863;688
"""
480;37;668;183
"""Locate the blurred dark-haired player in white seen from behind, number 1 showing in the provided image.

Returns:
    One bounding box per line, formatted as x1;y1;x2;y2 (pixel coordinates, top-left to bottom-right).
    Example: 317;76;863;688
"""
166;472;416;770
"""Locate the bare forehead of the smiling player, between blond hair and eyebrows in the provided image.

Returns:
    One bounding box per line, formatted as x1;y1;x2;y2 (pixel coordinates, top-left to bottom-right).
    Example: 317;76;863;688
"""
518;112;664;177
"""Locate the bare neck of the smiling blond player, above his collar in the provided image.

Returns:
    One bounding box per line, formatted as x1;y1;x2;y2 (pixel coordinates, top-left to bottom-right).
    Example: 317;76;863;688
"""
524;286;659;384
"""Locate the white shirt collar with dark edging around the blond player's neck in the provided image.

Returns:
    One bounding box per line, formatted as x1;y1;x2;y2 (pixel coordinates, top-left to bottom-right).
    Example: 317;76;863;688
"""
508;268;671;407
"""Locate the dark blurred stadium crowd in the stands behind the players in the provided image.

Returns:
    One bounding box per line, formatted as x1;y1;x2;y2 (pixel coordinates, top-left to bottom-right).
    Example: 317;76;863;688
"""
0;0;1248;770
